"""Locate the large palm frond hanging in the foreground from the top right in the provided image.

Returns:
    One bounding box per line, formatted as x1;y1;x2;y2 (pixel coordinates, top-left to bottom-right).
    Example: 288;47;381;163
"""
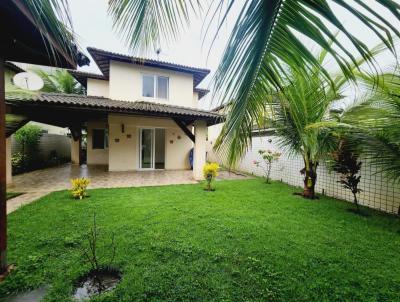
214;0;400;163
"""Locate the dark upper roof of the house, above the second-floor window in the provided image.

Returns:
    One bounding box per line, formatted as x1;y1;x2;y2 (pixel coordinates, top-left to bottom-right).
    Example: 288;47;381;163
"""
87;47;210;87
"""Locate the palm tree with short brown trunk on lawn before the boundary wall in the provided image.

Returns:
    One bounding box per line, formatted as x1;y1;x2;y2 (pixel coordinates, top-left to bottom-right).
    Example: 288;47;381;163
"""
222;51;347;199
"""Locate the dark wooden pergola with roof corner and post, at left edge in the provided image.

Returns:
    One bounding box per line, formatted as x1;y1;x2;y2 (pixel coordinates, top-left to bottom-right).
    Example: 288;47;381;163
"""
0;0;89;280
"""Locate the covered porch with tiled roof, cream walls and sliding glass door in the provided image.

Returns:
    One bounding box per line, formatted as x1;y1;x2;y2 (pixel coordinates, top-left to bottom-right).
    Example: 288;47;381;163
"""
6;93;222;186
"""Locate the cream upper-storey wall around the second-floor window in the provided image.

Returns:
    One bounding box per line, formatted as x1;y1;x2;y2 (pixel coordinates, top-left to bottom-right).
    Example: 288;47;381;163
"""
109;61;193;107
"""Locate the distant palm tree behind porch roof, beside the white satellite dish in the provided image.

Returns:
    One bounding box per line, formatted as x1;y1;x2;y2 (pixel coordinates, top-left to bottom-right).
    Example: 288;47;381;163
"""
33;69;85;94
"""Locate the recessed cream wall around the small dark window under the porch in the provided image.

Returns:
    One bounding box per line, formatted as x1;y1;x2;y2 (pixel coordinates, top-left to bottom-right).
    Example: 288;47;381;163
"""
86;121;109;165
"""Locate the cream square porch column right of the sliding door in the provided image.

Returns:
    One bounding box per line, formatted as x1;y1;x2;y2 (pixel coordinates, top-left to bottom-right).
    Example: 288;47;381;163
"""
193;121;207;180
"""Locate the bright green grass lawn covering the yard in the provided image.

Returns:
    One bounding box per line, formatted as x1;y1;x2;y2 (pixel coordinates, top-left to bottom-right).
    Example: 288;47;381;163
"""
0;179;400;301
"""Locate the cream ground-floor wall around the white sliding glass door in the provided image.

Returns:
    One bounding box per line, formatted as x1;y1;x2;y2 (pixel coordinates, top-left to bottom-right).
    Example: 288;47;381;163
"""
108;115;193;171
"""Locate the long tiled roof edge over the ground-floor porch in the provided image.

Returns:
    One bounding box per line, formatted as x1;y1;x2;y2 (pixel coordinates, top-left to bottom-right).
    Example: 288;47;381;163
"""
6;93;223;125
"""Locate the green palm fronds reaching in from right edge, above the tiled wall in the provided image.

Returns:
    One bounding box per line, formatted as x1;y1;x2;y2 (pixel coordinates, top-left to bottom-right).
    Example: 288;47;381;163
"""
330;68;400;182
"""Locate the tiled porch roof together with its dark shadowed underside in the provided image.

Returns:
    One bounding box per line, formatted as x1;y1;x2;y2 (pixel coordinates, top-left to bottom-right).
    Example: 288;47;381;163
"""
6;93;223;133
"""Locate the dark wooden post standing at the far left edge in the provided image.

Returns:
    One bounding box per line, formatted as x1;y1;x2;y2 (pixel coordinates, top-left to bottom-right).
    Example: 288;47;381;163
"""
0;56;7;275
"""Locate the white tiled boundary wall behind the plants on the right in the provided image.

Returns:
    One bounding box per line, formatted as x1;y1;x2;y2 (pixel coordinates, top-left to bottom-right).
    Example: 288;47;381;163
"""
207;136;400;214
